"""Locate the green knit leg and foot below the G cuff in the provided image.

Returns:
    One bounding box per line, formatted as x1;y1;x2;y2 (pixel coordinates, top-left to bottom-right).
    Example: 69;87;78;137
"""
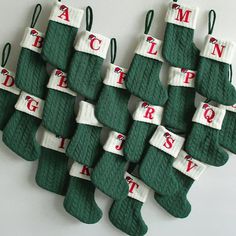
2;110;41;161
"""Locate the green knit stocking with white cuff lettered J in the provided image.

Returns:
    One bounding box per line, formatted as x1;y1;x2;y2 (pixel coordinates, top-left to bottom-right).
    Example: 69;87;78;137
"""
91;131;129;200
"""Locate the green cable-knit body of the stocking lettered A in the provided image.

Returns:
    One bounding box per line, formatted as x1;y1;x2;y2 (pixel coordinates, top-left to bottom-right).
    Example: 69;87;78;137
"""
42;20;78;71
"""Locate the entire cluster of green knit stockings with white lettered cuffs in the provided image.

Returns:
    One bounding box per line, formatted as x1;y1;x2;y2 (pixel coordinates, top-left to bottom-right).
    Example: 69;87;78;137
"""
0;0;236;236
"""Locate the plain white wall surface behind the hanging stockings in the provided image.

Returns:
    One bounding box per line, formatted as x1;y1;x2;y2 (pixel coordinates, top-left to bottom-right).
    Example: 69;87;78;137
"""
0;0;236;236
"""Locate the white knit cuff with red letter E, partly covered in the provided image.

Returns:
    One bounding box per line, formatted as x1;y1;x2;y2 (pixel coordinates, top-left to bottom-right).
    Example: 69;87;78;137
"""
47;69;77;96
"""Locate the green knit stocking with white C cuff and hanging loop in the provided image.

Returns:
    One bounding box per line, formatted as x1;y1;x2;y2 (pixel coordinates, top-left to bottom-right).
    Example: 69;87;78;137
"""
68;7;110;101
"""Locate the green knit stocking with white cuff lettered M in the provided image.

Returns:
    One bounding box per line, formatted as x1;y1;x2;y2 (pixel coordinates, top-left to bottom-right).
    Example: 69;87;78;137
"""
163;0;200;70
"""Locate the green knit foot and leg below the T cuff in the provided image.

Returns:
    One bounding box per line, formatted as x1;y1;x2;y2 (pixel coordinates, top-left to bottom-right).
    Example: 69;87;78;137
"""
109;197;148;236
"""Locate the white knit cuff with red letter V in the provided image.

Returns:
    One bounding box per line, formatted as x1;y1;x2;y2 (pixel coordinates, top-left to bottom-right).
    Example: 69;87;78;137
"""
173;150;207;180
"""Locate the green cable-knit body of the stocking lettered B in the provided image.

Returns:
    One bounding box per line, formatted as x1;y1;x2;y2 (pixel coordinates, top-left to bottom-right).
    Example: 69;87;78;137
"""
15;48;49;98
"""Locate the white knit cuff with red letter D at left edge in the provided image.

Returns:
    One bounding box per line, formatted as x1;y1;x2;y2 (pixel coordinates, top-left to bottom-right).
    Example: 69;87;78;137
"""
0;66;20;95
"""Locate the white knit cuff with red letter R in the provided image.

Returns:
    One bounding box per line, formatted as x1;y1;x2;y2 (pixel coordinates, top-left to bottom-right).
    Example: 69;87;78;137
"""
133;101;164;125
